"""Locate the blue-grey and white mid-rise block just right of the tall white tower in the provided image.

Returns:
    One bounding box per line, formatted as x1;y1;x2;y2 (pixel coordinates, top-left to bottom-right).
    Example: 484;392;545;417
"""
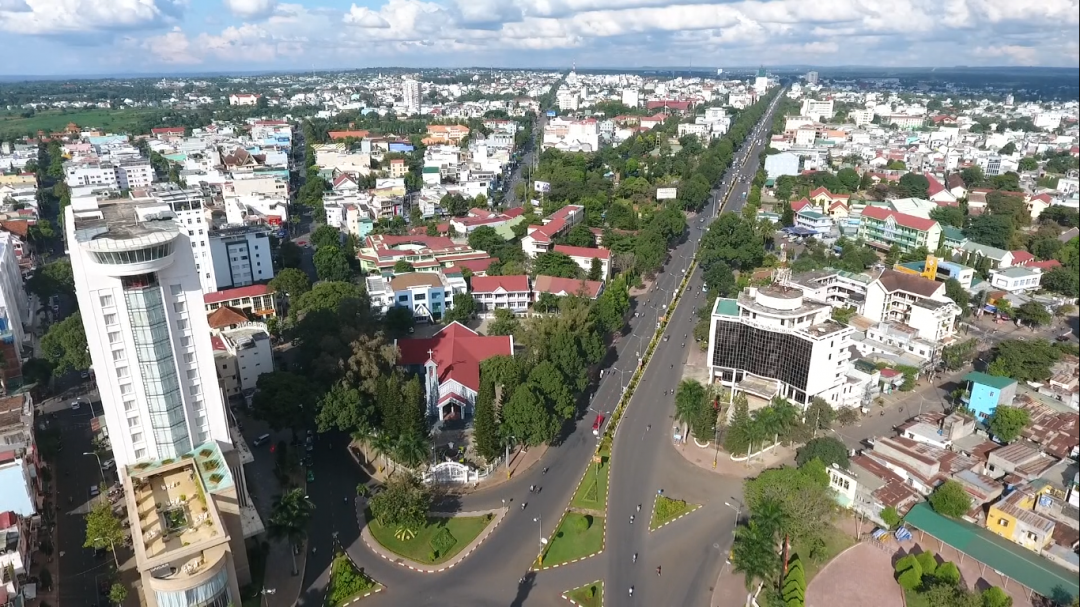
204;226;273;293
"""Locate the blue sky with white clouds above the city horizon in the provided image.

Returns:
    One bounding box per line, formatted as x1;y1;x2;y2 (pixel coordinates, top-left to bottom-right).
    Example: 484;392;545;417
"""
0;0;1080;76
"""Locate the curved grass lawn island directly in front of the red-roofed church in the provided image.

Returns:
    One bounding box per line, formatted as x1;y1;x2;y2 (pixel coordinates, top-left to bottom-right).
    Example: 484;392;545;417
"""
366;510;491;565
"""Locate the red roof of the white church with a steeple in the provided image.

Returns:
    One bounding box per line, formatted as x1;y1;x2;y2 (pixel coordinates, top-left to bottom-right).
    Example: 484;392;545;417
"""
397;322;514;391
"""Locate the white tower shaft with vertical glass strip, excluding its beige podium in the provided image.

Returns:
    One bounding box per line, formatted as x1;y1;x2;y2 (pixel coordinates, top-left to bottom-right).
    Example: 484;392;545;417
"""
64;199;232;467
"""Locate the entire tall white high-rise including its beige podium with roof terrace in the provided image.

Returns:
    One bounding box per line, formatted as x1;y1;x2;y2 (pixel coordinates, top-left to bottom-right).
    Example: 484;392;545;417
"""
64;198;264;607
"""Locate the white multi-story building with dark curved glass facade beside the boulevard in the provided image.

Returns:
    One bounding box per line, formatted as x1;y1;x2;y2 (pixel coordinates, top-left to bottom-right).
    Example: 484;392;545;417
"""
708;285;854;407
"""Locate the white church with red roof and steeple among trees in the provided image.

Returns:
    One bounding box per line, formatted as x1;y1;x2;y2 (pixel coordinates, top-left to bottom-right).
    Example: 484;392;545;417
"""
395;322;514;424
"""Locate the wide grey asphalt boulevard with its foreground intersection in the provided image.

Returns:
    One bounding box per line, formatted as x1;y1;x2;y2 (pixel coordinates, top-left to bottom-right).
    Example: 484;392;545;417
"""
298;92;790;607
